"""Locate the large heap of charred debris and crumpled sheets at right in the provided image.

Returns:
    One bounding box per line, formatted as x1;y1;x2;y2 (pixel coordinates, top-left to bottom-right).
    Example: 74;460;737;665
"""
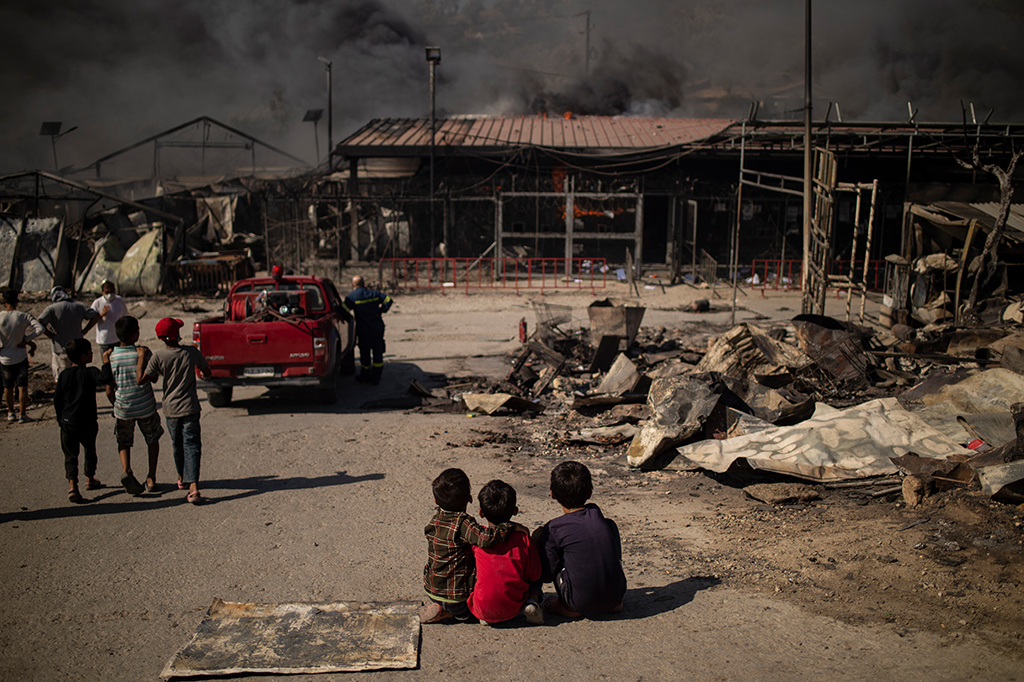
403;294;1024;507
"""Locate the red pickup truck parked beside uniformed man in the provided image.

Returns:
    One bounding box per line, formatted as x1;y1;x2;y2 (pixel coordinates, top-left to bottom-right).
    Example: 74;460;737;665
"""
193;275;355;408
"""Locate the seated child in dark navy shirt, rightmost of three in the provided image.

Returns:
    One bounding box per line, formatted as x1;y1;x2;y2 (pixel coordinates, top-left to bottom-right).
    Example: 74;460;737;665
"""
535;462;626;617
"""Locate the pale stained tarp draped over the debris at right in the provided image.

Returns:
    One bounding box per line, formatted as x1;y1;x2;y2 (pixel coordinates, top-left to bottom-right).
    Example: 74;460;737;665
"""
668;398;971;480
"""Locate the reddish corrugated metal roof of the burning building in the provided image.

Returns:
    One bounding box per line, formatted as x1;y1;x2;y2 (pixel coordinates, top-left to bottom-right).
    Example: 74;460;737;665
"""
338;116;736;156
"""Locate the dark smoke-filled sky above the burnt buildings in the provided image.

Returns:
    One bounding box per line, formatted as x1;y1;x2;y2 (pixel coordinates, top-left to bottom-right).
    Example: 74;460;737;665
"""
0;0;1024;172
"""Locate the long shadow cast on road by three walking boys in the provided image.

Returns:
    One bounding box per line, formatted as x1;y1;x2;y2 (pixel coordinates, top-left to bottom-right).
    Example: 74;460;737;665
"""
0;471;384;524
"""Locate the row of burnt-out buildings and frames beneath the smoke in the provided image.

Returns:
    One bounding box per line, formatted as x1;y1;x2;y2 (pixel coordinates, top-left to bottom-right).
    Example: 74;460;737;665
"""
0;108;1024;324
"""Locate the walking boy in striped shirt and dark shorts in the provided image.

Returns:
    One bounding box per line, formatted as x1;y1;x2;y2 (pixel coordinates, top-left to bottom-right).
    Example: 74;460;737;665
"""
103;315;164;495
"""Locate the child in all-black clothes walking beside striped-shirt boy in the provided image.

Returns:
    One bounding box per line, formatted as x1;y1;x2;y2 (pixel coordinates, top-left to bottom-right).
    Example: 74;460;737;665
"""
53;339;111;504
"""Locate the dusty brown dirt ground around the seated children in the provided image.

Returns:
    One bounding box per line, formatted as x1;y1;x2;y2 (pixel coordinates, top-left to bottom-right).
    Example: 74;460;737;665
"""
0;274;1024;680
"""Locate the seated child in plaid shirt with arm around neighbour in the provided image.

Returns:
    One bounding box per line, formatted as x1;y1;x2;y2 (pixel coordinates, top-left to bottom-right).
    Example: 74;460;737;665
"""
420;469;514;624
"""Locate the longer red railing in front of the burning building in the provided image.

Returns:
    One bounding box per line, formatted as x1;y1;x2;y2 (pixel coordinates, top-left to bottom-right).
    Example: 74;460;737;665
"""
380;258;608;294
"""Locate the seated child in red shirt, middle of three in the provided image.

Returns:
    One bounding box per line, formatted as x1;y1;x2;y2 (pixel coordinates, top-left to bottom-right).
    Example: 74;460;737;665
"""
468;479;544;625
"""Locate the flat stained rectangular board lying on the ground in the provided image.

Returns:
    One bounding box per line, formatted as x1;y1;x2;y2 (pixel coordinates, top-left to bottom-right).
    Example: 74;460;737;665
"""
161;599;420;678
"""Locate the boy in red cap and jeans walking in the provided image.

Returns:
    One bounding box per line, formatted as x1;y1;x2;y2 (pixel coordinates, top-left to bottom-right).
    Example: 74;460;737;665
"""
136;317;210;505
